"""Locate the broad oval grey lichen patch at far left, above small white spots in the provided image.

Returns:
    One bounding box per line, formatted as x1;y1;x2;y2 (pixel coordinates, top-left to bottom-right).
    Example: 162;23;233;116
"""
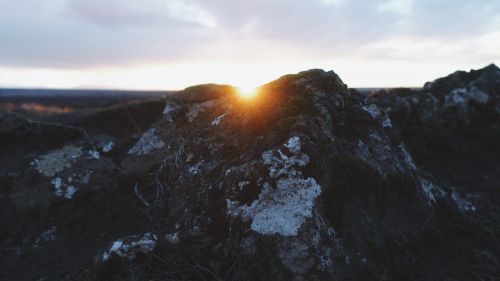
32;145;83;177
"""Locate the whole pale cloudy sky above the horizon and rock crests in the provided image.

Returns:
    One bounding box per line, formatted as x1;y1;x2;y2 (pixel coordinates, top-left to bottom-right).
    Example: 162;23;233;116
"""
0;0;500;90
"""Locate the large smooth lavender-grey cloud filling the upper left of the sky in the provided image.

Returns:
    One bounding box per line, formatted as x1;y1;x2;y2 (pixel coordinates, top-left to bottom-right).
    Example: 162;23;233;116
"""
0;0;218;68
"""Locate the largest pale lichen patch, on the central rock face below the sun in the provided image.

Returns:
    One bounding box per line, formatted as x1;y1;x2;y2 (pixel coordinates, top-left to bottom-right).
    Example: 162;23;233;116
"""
228;137;321;236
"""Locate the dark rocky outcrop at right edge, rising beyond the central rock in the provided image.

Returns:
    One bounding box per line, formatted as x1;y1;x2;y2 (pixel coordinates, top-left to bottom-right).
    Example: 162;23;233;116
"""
362;65;500;279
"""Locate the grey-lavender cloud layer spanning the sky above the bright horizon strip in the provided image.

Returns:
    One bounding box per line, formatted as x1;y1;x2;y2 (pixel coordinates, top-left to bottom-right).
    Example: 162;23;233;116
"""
0;0;500;87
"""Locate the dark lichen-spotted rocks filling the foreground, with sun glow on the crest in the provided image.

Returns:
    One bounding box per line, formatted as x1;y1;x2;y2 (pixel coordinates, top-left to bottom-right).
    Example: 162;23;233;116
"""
0;66;500;280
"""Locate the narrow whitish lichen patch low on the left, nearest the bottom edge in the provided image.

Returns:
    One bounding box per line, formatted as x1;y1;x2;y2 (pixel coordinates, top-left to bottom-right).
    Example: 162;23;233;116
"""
102;233;157;261
